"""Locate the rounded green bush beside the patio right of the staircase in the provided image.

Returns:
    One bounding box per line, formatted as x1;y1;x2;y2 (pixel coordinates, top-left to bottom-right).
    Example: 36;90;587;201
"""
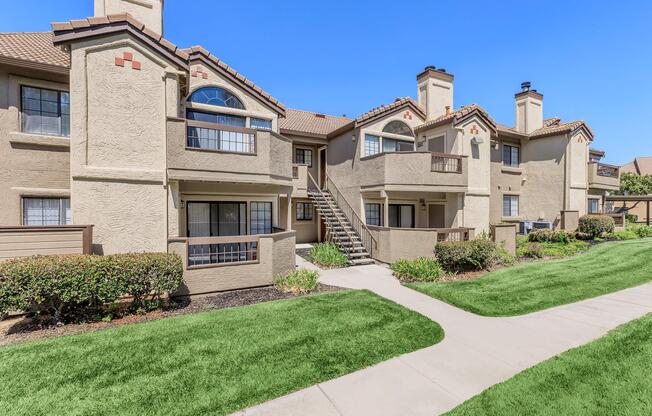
435;237;496;272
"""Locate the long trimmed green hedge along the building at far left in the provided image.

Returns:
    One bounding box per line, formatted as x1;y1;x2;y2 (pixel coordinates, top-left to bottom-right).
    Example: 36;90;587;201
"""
0;253;183;322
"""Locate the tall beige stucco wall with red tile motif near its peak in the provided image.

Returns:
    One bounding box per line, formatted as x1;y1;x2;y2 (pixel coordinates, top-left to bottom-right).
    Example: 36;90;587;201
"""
71;34;178;254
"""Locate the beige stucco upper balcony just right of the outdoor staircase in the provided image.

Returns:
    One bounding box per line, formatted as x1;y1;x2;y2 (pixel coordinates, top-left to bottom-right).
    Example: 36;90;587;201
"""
359;152;468;192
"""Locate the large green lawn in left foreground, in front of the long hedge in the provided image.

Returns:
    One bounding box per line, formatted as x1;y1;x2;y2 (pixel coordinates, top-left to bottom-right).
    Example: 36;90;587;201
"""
0;291;443;416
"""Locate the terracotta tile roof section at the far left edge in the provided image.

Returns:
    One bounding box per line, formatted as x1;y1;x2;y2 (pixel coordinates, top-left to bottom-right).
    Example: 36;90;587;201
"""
0;32;70;68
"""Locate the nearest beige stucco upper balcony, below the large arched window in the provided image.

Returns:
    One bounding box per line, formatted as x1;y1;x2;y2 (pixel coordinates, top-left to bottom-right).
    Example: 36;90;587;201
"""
167;119;292;186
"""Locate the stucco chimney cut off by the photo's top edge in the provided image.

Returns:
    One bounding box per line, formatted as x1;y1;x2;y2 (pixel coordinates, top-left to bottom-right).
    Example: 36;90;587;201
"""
95;0;164;35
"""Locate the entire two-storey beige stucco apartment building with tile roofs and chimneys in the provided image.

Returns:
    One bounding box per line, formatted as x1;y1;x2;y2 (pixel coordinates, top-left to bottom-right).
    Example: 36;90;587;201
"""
0;0;618;294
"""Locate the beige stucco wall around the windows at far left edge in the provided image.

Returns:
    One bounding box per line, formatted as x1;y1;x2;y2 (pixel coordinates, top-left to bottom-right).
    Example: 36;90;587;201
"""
0;66;70;225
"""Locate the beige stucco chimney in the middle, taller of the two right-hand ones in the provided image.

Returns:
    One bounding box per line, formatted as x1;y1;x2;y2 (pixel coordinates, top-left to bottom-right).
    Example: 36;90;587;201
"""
417;66;455;120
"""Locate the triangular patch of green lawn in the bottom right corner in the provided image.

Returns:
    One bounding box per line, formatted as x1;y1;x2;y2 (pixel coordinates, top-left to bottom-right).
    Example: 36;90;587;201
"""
448;315;652;416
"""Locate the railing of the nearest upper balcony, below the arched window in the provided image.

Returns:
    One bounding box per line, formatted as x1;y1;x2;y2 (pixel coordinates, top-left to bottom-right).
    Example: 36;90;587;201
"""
186;120;256;154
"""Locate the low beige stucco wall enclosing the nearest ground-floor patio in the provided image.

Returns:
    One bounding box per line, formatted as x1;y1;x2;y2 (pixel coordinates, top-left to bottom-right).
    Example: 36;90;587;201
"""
169;231;296;295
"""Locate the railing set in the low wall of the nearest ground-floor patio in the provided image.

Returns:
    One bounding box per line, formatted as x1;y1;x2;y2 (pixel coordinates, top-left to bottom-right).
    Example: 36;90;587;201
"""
186;235;260;269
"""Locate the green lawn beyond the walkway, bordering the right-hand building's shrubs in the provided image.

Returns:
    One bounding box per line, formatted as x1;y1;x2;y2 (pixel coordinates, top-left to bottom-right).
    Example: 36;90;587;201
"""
408;239;652;316
